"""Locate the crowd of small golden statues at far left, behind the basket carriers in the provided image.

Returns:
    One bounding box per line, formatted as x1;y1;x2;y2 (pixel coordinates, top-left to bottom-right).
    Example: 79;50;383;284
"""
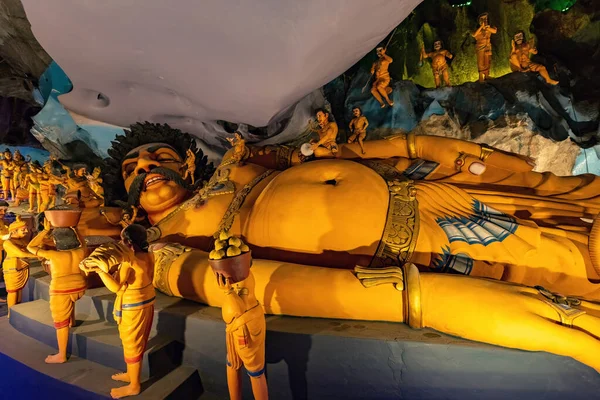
0;149;104;213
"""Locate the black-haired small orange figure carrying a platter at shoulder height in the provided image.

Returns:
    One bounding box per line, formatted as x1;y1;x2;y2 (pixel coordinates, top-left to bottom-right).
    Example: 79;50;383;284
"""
80;224;155;399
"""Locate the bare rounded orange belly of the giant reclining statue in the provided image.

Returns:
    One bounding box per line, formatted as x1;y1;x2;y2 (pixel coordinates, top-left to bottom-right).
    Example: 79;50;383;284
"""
244;160;389;255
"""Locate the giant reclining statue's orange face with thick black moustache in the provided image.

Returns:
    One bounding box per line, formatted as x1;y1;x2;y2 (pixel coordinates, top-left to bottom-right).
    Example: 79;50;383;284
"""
121;143;188;213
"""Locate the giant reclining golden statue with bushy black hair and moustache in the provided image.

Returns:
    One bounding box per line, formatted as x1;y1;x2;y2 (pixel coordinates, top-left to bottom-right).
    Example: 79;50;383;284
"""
84;123;600;371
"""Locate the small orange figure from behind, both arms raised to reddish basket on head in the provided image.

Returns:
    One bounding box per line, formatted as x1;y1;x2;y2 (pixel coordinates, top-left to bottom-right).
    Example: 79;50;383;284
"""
27;211;87;364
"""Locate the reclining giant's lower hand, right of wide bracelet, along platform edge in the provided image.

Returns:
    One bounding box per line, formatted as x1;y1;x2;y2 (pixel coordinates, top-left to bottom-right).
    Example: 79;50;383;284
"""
420;274;600;372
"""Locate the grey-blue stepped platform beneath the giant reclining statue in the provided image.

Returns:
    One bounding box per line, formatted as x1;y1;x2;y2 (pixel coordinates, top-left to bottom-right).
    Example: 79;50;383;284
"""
10;267;600;400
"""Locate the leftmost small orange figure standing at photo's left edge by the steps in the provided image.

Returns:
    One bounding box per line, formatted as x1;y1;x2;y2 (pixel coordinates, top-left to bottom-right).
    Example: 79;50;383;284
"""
2;215;33;318
